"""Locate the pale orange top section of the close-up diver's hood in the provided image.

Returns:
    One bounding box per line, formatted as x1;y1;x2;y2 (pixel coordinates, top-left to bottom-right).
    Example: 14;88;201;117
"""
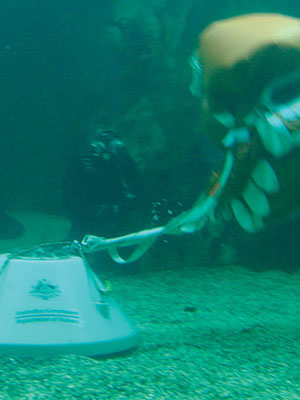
197;14;300;70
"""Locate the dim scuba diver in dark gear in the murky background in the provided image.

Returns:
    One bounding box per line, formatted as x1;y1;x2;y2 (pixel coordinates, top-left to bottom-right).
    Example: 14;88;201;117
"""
63;129;146;239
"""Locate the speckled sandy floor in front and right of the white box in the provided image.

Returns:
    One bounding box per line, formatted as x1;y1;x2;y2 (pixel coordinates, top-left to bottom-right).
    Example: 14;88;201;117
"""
0;265;300;400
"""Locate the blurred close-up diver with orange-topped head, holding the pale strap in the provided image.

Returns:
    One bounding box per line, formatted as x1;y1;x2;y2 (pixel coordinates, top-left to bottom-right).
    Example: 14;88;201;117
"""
190;13;300;233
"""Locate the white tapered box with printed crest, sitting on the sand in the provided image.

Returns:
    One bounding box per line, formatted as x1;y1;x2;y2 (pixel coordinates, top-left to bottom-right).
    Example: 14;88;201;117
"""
0;242;138;357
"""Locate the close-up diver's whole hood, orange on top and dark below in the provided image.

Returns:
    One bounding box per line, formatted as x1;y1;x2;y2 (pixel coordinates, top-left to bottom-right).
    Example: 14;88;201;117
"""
196;14;300;117
